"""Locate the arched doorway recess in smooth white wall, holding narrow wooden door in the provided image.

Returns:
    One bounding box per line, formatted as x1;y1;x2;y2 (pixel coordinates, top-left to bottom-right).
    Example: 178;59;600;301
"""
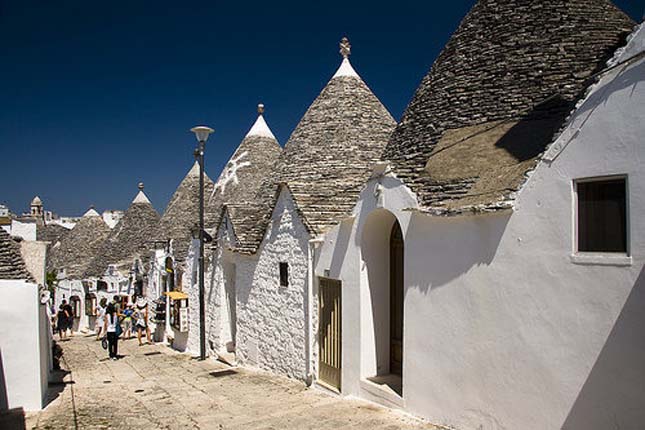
360;209;405;396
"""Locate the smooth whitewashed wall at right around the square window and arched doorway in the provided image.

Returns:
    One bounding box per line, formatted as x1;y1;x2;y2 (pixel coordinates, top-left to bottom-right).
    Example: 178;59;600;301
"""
317;35;645;430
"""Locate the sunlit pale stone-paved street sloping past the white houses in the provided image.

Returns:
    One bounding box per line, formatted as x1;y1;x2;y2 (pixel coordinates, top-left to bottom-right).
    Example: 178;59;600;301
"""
27;335;435;430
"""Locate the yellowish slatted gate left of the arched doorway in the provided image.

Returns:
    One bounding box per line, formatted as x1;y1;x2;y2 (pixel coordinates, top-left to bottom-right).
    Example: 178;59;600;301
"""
318;278;341;391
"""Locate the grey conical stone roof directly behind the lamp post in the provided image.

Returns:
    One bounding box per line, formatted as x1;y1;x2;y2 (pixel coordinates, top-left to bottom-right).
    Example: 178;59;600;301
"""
157;162;216;262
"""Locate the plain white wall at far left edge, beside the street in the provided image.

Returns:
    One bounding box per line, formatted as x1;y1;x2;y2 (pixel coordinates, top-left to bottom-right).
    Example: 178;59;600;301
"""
0;280;51;410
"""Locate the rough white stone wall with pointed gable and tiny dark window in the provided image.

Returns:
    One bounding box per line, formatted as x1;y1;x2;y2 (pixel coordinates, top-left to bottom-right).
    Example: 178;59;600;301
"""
236;191;309;379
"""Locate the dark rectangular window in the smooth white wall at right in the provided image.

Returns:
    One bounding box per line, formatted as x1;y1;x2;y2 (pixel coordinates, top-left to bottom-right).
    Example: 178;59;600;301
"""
576;178;627;253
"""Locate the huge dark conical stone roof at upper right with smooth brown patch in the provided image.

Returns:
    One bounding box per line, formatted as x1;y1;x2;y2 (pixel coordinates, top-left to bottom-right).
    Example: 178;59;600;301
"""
384;0;634;213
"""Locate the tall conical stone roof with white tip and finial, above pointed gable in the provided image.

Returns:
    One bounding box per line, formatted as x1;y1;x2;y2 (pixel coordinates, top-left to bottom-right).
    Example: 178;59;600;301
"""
254;39;396;239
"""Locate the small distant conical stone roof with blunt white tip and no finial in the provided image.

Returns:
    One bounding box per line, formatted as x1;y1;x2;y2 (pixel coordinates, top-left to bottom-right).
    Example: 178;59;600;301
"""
50;208;110;279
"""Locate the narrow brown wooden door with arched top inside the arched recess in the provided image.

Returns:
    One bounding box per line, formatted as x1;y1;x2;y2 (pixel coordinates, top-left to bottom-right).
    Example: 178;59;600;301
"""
390;222;403;375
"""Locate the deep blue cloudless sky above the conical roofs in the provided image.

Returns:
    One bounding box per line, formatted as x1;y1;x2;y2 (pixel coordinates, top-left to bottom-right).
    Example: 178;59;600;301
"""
0;0;645;215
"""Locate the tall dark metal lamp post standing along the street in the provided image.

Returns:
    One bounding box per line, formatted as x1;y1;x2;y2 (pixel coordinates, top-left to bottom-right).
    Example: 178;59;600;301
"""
190;125;214;360
